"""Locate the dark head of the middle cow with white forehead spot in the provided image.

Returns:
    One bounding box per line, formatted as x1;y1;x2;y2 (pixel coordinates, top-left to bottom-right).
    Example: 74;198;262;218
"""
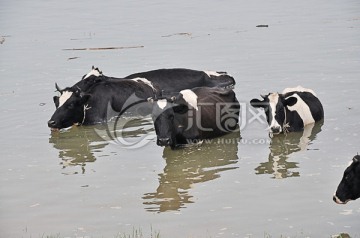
149;90;196;148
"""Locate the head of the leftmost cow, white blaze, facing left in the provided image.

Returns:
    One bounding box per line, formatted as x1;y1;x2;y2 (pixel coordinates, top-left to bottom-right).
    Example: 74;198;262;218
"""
48;84;90;130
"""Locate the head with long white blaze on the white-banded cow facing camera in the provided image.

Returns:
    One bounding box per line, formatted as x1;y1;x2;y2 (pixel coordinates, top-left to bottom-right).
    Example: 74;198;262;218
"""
250;93;297;134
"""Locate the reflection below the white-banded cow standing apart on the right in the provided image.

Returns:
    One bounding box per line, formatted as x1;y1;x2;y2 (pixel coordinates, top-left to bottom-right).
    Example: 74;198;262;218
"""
255;121;323;178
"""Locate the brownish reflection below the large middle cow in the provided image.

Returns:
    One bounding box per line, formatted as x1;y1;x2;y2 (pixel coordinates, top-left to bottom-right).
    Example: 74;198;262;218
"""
143;131;240;212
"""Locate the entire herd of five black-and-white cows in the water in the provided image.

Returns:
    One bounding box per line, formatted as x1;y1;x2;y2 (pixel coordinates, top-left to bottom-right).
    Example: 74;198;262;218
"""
48;67;360;204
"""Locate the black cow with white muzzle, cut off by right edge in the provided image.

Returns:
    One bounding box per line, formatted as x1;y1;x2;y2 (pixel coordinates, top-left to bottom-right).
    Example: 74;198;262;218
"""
333;155;360;204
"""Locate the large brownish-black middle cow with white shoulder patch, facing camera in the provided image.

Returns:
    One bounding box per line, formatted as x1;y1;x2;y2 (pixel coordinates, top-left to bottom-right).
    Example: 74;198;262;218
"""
148;87;240;149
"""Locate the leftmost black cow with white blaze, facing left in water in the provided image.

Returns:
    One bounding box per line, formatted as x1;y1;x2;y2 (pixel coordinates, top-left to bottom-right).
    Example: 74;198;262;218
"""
48;79;157;130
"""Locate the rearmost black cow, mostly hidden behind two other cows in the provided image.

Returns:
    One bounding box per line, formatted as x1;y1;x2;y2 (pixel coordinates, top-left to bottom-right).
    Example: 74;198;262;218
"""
68;66;235;92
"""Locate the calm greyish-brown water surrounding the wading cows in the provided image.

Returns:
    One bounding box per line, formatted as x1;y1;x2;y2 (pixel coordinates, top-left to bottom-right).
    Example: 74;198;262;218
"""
0;0;360;237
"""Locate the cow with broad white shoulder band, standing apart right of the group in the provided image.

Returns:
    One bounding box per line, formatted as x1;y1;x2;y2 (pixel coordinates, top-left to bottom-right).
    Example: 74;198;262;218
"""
250;86;324;135
